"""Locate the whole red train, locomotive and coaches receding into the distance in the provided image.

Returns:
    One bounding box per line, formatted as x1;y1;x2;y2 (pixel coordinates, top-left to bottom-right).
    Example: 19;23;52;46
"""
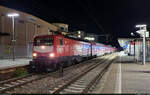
30;35;116;71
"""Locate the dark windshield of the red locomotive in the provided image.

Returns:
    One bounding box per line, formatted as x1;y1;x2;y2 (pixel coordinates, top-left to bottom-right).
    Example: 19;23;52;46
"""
34;37;54;46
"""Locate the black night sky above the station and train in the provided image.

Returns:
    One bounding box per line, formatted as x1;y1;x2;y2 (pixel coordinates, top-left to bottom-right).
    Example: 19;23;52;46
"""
0;0;150;45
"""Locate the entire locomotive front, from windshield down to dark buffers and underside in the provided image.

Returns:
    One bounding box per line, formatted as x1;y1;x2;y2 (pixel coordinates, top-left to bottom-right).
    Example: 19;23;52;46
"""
30;35;55;71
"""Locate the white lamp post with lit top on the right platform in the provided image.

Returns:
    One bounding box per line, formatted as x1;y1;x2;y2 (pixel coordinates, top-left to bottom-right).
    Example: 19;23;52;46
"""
136;24;147;65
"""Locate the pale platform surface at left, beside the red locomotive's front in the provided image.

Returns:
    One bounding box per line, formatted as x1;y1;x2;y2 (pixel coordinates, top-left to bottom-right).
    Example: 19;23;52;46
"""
0;58;32;70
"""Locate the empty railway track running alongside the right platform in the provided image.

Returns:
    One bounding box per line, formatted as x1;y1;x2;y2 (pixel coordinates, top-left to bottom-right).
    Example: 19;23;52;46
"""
51;53;114;94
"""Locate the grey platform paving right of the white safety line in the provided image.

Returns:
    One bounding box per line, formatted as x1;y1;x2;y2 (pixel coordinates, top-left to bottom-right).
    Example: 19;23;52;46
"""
121;63;150;93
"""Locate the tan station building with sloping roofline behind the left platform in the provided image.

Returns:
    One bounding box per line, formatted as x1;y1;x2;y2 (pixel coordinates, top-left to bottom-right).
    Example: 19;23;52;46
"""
0;6;68;59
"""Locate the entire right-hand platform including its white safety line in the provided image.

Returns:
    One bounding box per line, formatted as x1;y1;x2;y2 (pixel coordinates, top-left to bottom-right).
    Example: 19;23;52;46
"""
93;56;150;94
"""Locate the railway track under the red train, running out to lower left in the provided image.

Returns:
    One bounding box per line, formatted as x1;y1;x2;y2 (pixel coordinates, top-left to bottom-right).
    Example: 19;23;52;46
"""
0;55;105;93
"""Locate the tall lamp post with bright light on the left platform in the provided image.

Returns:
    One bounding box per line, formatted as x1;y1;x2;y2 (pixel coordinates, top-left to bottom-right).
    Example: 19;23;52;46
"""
7;13;19;61
